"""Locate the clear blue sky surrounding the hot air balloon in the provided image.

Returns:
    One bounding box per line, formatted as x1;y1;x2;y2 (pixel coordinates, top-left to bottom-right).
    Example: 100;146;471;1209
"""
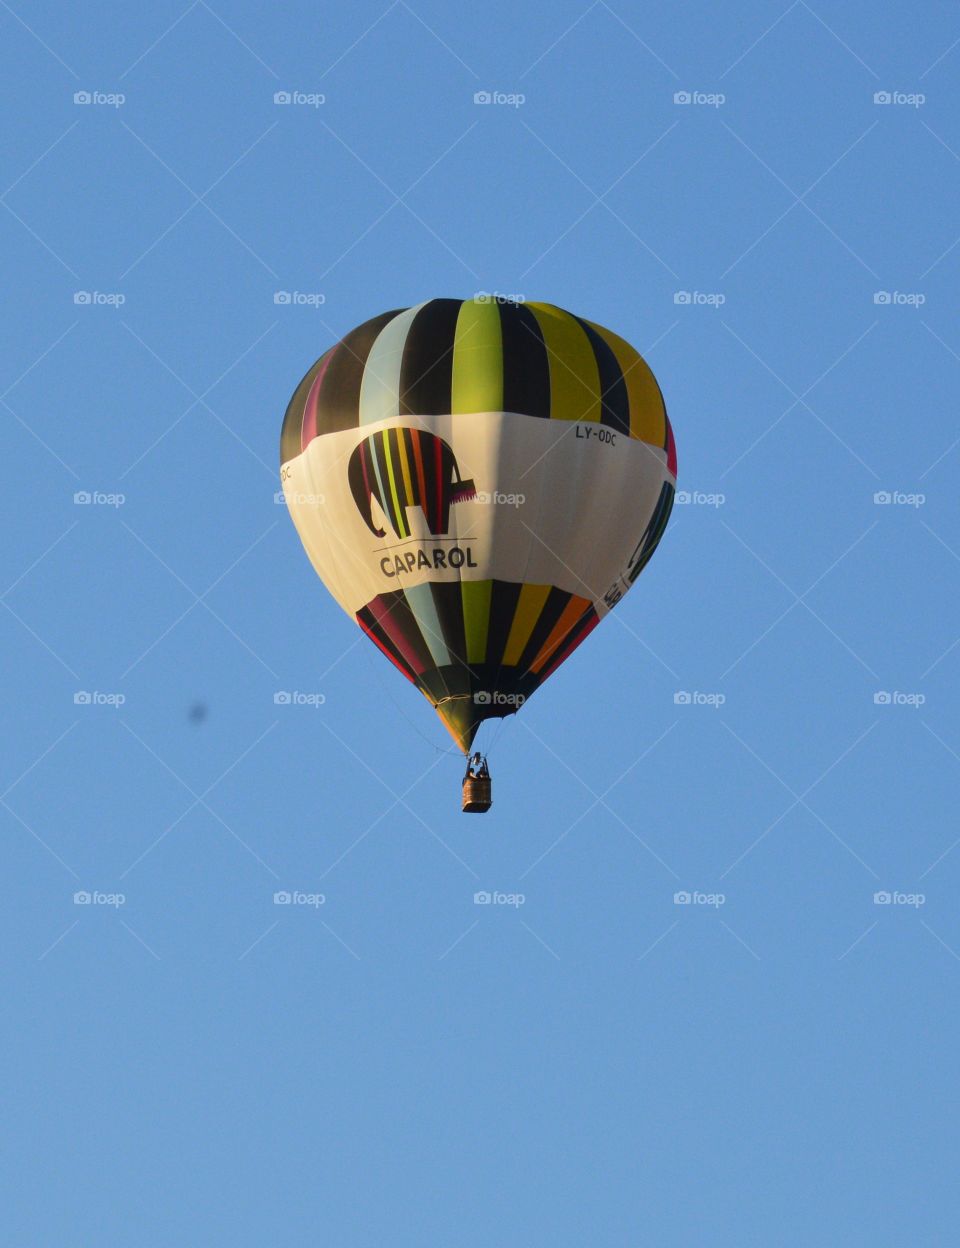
0;0;960;1248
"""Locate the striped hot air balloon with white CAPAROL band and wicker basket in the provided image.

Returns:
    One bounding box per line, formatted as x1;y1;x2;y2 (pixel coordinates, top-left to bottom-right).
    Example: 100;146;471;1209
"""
280;296;677;810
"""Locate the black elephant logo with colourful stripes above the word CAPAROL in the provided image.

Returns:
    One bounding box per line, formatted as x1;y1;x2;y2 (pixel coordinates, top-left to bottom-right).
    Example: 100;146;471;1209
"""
347;428;477;538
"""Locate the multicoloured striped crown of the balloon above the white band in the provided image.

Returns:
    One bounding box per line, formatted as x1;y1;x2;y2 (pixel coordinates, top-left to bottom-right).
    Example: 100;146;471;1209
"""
281;297;675;464
